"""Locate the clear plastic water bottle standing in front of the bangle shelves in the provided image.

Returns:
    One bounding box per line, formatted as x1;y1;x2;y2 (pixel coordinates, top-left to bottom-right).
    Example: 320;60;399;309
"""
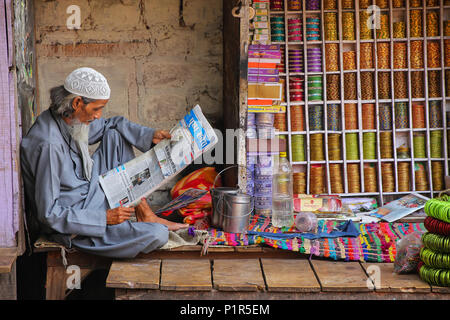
272;152;294;228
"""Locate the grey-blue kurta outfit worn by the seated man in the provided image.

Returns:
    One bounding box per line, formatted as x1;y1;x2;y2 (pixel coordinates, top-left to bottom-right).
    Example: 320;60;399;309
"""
21;110;168;258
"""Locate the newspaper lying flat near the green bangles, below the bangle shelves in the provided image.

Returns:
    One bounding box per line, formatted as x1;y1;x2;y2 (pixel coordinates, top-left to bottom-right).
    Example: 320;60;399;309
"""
367;193;430;222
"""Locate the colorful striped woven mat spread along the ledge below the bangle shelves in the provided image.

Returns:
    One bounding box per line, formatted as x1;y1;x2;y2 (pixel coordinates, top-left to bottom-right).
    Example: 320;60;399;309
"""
209;215;426;262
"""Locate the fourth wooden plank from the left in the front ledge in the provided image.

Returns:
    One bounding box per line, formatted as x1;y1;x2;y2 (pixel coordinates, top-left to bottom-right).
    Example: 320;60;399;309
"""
261;259;320;292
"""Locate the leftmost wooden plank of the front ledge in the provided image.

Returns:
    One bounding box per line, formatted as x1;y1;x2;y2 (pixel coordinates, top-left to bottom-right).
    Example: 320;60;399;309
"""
106;259;161;289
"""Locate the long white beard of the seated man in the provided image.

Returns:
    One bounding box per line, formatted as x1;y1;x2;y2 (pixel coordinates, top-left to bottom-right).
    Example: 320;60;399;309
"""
69;119;94;181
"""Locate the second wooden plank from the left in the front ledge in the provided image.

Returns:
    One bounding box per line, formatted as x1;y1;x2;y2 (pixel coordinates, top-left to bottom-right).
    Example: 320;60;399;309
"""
160;259;212;291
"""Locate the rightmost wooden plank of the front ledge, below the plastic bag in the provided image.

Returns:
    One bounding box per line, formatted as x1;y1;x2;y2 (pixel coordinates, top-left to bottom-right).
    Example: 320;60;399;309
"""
362;263;431;293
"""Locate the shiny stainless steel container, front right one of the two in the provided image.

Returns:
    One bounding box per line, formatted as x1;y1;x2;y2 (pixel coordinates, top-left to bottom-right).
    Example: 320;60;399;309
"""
222;193;253;233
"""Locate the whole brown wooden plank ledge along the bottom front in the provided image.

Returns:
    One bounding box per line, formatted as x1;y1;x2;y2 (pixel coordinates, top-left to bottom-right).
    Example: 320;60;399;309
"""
106;255;450;300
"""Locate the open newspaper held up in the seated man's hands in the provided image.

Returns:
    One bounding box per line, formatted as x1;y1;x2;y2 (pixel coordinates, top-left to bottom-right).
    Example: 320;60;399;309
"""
100;105;218;208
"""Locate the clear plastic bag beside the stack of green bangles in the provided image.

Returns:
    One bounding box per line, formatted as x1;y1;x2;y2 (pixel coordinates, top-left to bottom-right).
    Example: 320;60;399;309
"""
394;231;425;274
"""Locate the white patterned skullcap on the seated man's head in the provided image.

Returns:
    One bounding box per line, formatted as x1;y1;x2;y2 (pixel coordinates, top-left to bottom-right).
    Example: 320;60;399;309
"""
64;67;111;100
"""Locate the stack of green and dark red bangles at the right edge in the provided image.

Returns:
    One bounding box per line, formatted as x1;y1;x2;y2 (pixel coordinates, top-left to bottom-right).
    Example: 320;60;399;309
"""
418;194;450;287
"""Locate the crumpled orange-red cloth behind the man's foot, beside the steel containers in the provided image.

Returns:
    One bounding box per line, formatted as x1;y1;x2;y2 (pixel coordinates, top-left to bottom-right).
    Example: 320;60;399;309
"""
170;167;222;217
